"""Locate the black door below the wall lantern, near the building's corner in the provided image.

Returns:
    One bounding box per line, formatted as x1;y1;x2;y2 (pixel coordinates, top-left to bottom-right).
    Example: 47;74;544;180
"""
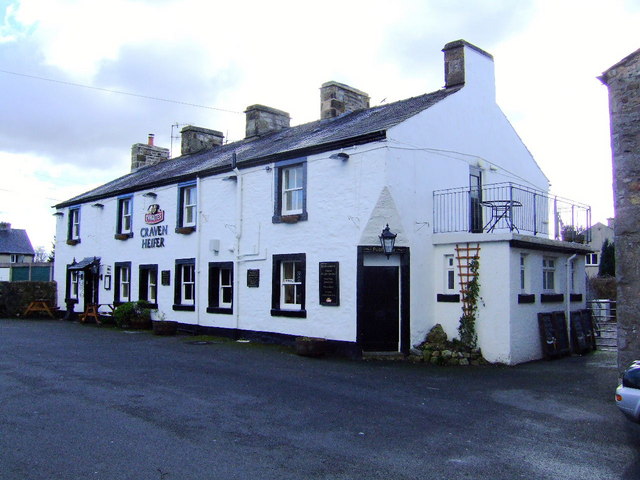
358;266;400;352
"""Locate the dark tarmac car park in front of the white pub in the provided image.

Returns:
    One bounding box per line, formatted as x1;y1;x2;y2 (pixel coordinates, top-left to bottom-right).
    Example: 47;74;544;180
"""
0;320;640;480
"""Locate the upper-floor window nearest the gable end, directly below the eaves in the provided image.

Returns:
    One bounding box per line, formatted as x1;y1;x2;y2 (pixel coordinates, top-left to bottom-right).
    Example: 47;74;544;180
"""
273;159;308;223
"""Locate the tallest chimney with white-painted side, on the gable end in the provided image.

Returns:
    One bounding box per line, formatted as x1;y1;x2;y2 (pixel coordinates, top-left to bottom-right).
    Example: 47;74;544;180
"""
442;40;495;100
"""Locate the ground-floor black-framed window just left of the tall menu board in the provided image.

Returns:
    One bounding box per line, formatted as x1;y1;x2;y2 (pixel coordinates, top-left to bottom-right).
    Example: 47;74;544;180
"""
271;253;306;317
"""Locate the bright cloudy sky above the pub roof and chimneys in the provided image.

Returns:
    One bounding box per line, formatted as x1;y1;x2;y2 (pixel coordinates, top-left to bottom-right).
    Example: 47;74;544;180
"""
0;0;640;250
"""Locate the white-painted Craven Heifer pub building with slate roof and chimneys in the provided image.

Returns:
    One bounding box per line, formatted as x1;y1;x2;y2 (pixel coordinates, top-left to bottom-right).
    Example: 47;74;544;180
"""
55;41;588;364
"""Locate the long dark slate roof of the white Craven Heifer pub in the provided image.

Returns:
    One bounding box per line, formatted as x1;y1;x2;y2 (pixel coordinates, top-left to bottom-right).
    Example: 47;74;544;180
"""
56;87;462;208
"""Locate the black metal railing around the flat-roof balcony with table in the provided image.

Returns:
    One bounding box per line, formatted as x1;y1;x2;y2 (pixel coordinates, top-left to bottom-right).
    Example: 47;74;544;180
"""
433;183;591;243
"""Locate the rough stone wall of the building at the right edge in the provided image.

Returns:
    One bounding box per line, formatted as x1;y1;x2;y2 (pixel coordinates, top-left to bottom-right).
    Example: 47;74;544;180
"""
600;49;640;370
